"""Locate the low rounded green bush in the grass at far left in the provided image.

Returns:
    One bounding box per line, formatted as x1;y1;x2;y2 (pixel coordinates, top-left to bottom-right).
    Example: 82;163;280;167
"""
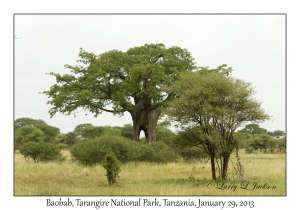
20;142;61;162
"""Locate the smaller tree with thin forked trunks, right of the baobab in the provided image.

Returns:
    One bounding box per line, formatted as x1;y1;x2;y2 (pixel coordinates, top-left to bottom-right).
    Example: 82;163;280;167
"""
166;68;269;179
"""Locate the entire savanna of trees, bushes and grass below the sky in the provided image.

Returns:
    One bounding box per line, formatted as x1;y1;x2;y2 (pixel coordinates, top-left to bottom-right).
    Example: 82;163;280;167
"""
14;44;286;195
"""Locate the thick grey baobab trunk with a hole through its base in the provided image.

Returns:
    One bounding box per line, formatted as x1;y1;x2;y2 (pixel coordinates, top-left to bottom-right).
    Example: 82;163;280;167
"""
130;101;161;144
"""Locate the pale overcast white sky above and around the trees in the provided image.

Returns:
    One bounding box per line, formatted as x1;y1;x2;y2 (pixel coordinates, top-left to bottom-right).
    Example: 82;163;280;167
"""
14;14;286;133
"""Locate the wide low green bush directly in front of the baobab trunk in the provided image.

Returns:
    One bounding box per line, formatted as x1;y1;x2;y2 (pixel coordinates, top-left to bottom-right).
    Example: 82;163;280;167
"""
70;135;178;166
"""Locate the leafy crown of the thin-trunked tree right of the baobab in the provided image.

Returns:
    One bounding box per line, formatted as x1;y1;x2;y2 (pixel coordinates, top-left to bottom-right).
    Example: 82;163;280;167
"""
166;71;269;130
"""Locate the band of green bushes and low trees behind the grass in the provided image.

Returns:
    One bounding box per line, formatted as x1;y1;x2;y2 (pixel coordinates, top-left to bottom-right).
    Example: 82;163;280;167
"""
14;118;286;166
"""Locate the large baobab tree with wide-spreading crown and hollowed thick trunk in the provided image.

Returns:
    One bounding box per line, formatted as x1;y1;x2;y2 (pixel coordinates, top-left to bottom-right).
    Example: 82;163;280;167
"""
43;44;195;143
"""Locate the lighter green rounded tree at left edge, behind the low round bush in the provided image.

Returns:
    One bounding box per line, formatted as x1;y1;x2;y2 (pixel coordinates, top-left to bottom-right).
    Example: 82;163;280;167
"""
15;126;46;149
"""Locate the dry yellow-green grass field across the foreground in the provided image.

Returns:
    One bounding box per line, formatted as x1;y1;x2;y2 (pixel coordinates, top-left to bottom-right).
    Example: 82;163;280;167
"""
14;151;286;196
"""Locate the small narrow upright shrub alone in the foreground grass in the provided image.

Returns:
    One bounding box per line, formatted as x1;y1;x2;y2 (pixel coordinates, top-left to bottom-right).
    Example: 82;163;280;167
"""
101;154;121;185
